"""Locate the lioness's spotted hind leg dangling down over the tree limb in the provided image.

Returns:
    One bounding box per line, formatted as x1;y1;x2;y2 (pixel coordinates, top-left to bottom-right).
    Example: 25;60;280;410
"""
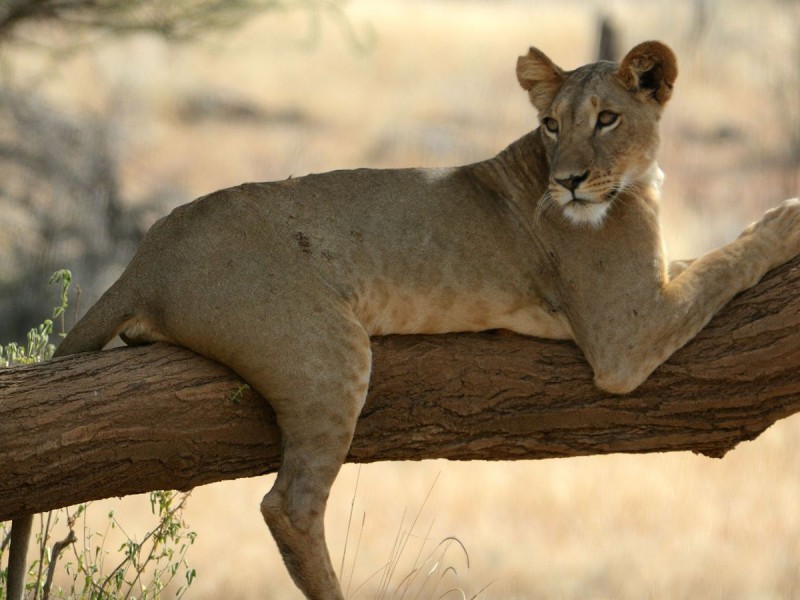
230;314;371;600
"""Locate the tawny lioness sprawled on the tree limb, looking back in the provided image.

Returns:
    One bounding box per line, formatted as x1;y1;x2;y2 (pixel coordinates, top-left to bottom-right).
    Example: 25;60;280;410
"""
9;42;800;600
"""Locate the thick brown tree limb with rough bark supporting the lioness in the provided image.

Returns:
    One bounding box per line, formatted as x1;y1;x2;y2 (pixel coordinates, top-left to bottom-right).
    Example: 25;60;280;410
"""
0;259;800;520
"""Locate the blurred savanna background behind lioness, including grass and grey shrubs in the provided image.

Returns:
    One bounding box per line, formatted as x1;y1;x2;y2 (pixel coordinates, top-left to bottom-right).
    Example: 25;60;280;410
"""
0;0;800;600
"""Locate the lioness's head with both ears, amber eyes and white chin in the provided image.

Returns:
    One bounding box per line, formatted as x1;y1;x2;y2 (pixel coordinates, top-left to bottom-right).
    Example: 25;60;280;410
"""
517;42;677;226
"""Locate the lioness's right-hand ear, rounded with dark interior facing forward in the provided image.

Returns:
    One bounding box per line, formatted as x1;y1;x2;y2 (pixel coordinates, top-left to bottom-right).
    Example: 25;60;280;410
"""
617;42;678;106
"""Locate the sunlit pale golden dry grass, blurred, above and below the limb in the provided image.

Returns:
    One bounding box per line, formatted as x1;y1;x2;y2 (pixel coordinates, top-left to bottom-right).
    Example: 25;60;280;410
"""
6;0;800;600
